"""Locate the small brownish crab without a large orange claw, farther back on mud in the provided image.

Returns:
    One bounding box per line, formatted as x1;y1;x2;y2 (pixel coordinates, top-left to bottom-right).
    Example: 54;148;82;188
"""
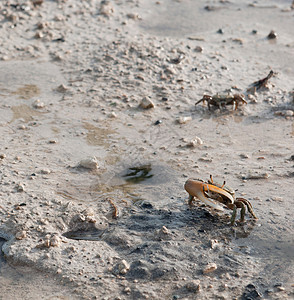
195;94;247;110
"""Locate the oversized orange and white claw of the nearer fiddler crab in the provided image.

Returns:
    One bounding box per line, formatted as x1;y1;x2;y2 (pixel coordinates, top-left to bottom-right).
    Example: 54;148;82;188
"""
184;179;224;210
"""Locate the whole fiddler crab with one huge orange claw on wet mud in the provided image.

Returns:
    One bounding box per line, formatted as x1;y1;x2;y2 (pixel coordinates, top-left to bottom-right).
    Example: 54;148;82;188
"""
185;175;257;225
